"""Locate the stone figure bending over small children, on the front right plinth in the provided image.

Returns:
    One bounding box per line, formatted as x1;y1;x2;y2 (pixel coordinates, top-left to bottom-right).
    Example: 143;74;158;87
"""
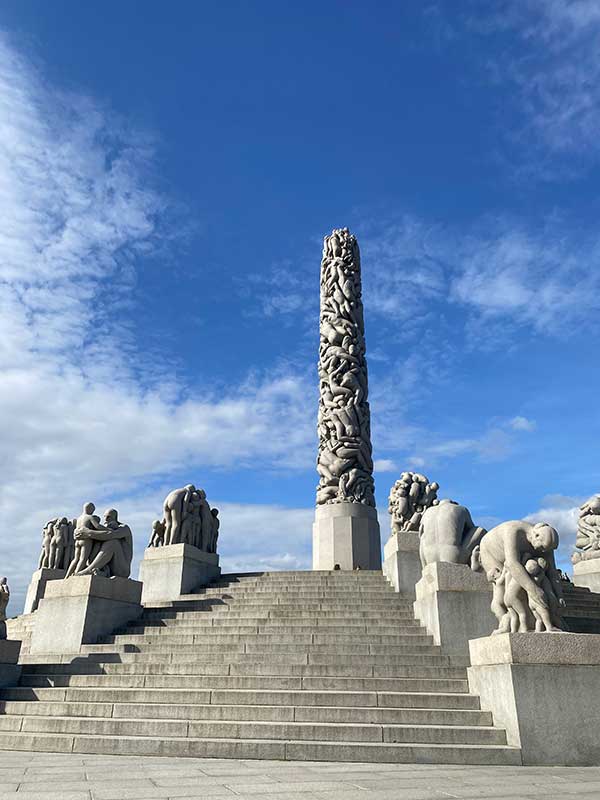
479;520;564;633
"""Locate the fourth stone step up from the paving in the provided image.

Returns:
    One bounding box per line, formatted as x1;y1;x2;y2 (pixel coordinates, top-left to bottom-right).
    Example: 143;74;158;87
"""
0;686;479;710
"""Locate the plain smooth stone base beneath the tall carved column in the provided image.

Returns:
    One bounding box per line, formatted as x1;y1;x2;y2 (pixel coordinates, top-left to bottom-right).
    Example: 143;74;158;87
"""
313;503;381;570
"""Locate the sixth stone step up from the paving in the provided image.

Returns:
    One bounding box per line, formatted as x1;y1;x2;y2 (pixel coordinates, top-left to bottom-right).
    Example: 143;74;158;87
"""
23;660;467;680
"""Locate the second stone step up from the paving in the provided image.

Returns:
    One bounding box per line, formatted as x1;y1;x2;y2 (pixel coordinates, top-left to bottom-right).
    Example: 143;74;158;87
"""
0;715;506;745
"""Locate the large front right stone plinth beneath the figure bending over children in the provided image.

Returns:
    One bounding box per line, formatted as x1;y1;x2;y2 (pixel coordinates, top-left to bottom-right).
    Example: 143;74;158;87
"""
468;633;600;766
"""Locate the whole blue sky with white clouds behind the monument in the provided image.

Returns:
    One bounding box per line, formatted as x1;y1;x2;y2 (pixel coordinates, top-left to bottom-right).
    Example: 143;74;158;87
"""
0;0;600;613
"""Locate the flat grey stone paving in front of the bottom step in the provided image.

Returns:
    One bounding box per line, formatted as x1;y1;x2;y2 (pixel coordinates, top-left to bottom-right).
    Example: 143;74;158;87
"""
0;752;600;800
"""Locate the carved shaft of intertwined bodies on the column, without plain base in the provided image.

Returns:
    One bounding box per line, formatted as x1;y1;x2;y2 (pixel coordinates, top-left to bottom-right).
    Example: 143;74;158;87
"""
317;228;375;506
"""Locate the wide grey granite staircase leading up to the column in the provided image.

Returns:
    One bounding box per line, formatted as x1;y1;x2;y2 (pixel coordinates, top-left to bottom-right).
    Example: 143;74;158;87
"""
0;571;521;764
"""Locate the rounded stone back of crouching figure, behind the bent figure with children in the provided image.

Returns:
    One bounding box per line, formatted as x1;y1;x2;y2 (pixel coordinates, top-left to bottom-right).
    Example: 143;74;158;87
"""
419;500;486;569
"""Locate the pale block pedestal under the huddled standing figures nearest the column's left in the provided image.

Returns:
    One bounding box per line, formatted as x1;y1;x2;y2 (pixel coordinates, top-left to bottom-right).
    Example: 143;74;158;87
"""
140;544;221;605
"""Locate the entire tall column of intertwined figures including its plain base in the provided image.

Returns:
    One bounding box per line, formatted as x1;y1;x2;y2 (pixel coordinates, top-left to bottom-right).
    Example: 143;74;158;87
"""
313;228;381;569
